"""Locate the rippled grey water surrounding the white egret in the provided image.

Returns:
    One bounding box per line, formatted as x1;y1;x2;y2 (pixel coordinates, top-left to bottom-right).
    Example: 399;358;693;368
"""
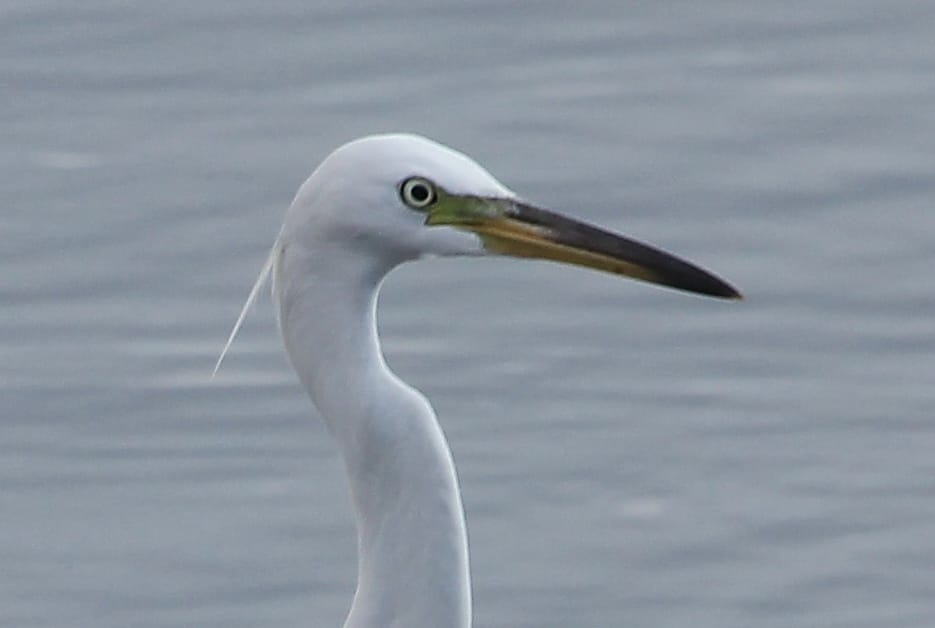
0;0;935;628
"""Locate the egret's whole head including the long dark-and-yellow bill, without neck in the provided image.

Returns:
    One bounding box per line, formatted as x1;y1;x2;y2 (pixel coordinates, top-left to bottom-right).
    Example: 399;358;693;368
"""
283;134;740;298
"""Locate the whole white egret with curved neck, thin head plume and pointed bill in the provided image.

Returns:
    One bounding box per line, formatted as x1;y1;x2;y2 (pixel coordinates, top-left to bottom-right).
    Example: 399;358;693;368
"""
215;134;740;628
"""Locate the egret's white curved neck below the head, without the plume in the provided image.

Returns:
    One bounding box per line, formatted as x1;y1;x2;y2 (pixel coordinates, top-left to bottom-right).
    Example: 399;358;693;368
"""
274;244;471;628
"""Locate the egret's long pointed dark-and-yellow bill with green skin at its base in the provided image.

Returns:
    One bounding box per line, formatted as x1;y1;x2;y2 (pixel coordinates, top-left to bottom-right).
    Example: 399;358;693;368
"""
426;196;742;299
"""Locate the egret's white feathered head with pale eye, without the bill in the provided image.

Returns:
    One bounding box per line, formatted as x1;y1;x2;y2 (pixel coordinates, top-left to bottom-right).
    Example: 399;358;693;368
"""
283;134;515;270
